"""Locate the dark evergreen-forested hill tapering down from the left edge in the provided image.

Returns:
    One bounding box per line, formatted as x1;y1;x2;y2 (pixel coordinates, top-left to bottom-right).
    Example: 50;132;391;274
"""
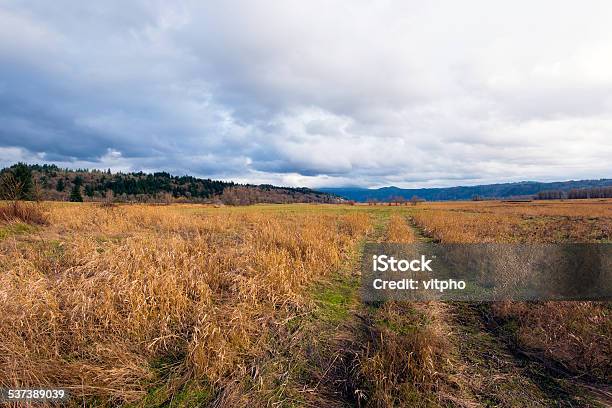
0;163;342;204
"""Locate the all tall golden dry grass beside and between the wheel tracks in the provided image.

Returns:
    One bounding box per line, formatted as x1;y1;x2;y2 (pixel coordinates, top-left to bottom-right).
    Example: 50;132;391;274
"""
0;201;612;407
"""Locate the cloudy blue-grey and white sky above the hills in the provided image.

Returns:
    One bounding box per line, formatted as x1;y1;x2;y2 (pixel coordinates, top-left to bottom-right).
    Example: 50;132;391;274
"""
0;0;612;188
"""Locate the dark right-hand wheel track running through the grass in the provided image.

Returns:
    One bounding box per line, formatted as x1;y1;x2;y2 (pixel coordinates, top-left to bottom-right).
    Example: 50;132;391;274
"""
408;218;606;407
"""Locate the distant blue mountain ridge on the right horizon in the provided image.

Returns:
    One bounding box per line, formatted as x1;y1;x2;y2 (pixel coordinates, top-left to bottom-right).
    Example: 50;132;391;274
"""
318;179;612;202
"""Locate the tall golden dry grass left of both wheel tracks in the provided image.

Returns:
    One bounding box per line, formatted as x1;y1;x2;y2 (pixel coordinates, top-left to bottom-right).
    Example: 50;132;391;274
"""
0;204;370;402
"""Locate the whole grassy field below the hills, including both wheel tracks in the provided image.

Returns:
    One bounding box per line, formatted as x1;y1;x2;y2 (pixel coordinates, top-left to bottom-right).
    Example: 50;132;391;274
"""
0;200;612;407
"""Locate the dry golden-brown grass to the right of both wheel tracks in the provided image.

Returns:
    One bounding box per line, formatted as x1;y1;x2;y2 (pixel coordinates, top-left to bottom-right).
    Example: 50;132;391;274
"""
414;200;612;381
